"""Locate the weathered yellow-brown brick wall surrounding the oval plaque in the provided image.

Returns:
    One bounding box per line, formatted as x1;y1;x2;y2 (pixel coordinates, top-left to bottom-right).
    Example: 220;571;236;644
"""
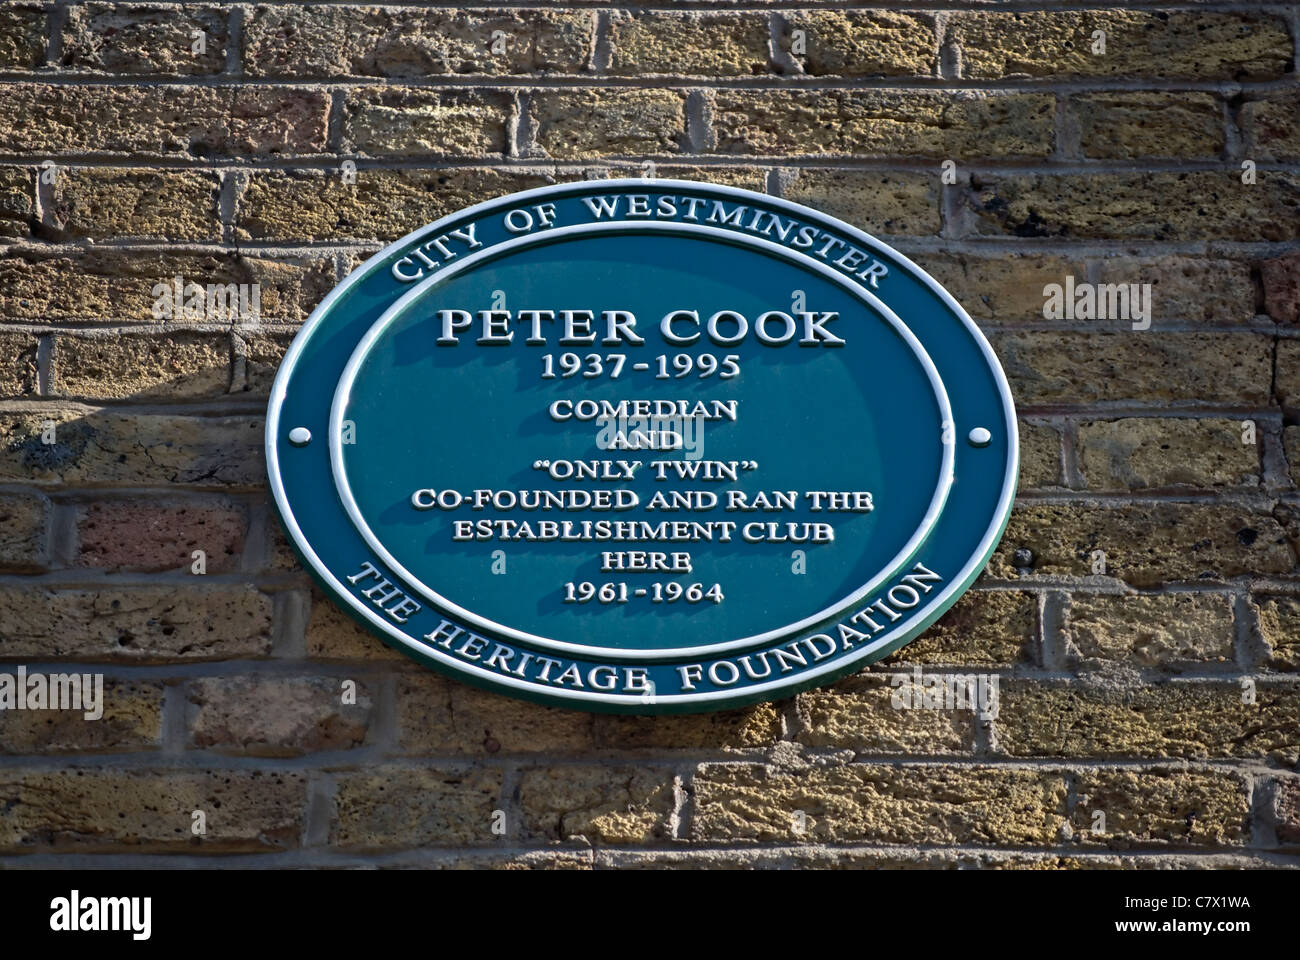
0;0;1300;868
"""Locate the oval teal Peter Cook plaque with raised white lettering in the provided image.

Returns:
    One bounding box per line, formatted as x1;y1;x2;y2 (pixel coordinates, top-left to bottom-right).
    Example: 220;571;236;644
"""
267;180;1018;713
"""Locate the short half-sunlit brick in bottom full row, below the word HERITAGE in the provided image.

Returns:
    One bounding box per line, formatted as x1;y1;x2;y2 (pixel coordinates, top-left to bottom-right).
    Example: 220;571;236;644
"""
519;765;673;843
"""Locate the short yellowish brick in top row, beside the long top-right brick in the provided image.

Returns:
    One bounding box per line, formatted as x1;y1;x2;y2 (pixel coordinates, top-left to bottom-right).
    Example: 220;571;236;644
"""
783;10;935;77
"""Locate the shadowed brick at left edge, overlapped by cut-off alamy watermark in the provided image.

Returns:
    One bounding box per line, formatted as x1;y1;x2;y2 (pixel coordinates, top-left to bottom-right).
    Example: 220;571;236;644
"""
0;669;163;753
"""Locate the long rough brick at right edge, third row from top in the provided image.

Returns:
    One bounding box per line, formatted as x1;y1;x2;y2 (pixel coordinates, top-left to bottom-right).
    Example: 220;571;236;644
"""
967;169;1300;242
